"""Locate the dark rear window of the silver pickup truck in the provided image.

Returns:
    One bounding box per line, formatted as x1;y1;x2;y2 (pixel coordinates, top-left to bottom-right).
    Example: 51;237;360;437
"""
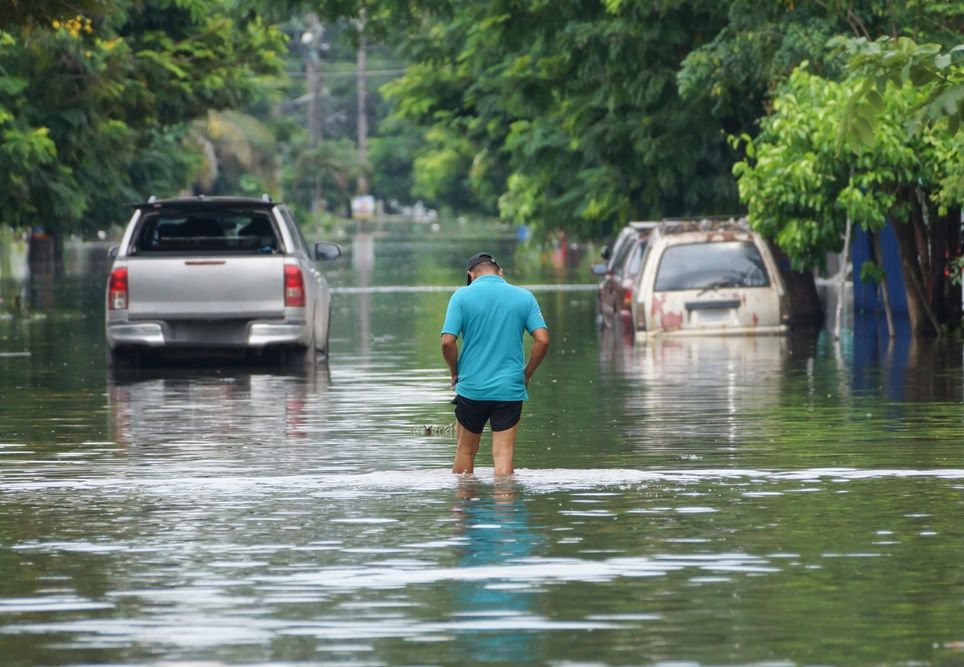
135;211;280;255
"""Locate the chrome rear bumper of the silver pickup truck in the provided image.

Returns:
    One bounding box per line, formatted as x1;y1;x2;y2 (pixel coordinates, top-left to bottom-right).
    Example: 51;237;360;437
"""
107;321;311;349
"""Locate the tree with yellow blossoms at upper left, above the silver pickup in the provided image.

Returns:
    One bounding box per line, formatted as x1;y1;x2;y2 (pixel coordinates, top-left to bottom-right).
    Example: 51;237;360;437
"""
0;0;284;248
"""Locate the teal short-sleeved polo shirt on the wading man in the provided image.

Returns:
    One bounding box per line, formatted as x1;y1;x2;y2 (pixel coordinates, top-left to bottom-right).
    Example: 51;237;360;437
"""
442;275;547;401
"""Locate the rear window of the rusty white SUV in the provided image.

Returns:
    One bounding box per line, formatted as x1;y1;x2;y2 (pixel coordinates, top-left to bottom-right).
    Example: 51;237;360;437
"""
656;241;770;292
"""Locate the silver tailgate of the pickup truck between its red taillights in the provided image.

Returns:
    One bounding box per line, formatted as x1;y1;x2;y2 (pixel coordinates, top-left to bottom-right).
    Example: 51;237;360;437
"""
127;256;284;320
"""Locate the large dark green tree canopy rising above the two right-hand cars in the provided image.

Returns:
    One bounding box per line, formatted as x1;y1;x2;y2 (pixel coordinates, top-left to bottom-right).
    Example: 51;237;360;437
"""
376;0;736;233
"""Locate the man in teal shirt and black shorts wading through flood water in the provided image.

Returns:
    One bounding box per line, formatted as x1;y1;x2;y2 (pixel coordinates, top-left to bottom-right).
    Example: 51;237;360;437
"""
442;252;549;475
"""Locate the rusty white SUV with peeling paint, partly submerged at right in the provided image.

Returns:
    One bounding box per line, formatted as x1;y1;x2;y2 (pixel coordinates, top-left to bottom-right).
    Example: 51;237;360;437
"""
631;219;790;339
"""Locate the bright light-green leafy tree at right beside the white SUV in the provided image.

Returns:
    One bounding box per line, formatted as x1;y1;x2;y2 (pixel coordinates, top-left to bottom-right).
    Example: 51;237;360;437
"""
734;64;960;333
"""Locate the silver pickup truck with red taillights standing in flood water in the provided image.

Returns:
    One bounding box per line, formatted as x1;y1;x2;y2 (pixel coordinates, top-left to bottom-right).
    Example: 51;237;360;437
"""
106;197;341;366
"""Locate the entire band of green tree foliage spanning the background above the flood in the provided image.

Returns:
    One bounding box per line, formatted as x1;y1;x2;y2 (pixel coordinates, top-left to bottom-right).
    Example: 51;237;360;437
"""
0;0;964;328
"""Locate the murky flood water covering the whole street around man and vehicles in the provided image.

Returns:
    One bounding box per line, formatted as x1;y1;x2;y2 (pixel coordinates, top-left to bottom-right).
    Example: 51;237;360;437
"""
0;228;964;667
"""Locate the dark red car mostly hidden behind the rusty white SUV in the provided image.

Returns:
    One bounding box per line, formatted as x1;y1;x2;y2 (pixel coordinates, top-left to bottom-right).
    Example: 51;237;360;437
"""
592;222;659;327
